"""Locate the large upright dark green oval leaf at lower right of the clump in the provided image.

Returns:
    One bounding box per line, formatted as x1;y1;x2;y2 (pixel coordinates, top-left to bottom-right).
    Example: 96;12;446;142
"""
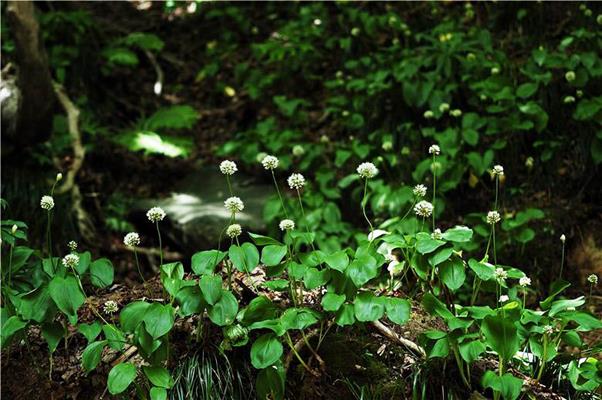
481;314;520;361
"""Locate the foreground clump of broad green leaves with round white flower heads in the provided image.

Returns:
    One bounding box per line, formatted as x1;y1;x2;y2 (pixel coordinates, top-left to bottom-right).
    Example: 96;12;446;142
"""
2;145;602;400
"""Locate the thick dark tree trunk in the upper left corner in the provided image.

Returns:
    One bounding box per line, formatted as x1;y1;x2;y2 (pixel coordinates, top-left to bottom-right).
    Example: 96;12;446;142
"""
6;1;56;146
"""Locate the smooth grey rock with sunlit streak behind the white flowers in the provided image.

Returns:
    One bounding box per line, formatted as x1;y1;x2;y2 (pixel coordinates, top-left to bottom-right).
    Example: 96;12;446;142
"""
140;168;274;253
